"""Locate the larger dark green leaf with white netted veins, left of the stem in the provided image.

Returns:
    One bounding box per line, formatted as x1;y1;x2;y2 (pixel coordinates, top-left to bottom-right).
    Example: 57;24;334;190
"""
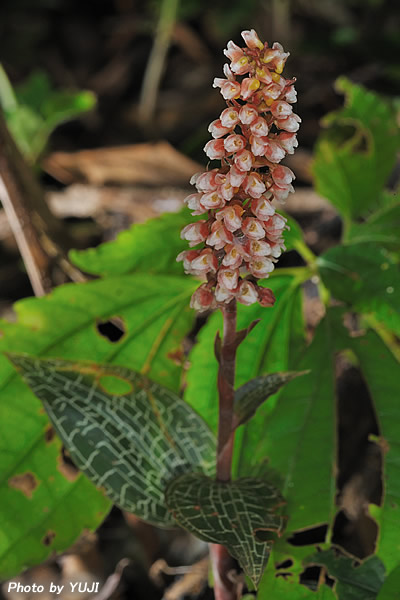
8;354;216;527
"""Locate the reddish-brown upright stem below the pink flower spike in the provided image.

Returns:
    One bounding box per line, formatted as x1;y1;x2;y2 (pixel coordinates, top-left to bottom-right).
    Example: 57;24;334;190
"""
210;300;238;600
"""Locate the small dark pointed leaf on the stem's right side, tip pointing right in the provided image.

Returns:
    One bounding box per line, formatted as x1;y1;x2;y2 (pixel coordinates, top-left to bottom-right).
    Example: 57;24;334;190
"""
234;371;308;427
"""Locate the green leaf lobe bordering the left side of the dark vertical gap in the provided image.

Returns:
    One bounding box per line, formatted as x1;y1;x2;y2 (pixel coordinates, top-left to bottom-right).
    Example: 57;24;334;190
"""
247;313;338;531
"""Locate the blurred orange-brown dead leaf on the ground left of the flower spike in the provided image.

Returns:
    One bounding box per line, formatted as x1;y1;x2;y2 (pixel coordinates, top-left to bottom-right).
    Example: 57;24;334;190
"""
42;142;203;186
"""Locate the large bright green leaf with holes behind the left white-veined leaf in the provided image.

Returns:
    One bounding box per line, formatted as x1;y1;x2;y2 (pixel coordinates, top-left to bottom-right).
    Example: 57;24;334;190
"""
0;275;195;577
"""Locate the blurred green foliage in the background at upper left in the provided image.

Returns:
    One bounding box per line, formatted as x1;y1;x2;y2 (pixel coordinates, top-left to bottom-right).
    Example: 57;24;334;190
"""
0;65;96;164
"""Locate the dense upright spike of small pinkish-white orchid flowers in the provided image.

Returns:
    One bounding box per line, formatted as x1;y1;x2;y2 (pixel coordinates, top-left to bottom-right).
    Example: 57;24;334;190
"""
177;29;301;311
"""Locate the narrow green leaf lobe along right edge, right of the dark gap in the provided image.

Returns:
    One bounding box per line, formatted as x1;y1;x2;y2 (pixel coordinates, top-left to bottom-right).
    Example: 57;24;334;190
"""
352;331;400;571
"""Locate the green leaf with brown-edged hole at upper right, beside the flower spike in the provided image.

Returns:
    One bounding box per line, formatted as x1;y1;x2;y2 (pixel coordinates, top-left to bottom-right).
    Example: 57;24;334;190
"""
313;77;400;221
